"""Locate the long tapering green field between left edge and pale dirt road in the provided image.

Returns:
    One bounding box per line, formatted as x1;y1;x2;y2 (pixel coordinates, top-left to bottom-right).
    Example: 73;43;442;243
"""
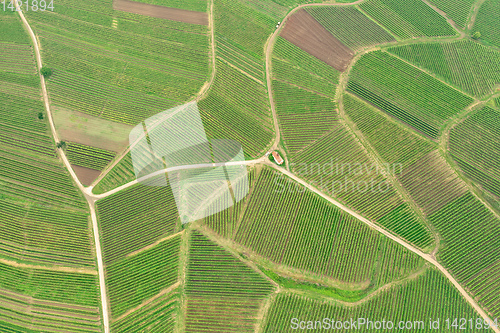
0;11;94;268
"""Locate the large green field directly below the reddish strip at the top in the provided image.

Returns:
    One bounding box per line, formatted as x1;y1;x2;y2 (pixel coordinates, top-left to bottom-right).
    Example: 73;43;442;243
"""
27;0;208;125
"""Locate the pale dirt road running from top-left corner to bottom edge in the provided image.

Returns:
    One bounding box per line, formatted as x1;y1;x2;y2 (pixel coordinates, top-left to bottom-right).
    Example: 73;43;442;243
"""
12;0;109;333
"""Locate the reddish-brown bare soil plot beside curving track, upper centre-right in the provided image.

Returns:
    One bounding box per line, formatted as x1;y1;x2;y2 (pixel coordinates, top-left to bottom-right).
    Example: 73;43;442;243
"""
280;9;354;72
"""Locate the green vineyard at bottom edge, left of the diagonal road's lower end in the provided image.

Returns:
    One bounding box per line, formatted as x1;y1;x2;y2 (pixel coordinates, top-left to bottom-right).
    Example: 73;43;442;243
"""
264;269;482;332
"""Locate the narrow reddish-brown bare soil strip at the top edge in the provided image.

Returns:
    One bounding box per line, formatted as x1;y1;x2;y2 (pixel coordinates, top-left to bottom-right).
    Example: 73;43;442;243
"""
113;0;208;25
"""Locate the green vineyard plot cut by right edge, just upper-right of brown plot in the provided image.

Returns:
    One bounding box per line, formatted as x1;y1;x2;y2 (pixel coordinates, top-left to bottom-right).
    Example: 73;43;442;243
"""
449;107;500;197
